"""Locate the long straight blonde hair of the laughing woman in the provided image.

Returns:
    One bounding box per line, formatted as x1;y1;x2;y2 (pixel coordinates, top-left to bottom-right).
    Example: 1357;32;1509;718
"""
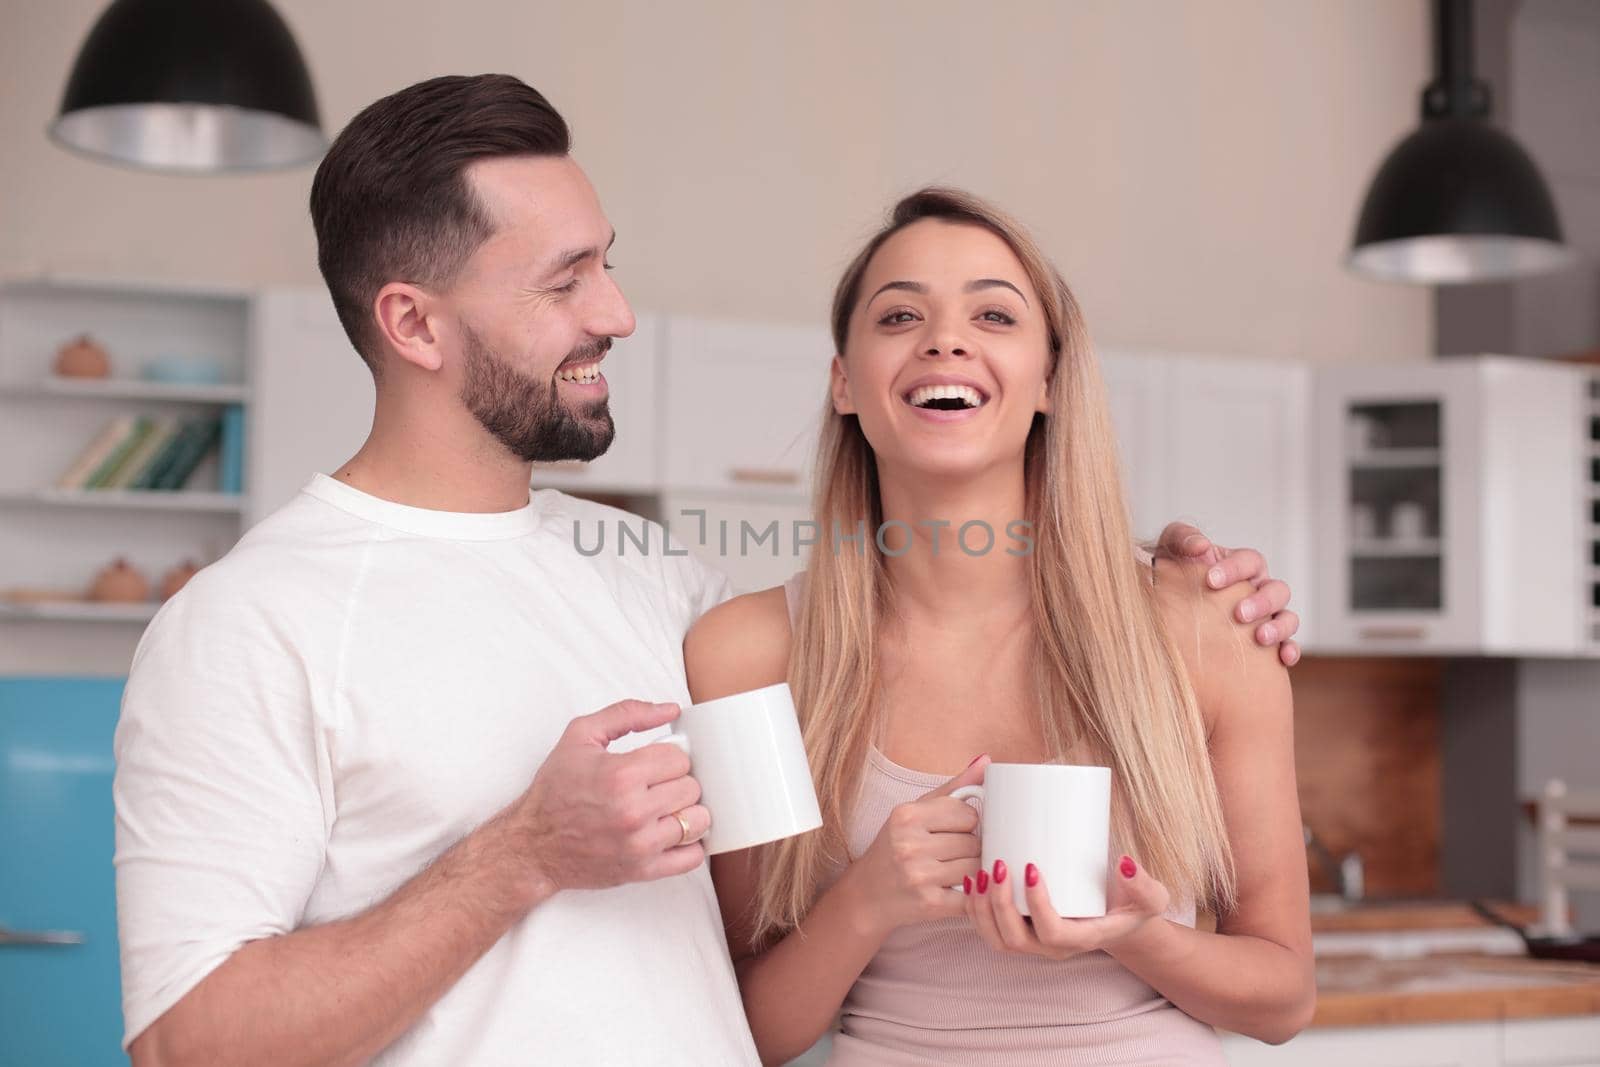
752;187;1234;945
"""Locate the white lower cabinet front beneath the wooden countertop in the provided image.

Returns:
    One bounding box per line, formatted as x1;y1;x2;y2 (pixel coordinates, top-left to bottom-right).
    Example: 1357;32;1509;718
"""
1221;1016;1600;1067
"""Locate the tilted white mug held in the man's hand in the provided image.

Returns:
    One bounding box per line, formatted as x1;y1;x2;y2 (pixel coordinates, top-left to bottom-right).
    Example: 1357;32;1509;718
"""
662;681;822;854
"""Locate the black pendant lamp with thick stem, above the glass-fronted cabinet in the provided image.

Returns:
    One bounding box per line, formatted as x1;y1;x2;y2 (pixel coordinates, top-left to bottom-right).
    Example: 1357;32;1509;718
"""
1347;0;1573;285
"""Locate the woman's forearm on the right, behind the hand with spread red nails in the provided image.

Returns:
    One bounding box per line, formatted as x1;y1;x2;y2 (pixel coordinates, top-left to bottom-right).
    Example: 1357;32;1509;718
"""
1109;920;1317;1045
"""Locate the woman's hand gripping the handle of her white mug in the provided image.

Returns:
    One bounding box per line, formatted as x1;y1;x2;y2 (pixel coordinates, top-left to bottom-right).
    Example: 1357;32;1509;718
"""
845;757;989;936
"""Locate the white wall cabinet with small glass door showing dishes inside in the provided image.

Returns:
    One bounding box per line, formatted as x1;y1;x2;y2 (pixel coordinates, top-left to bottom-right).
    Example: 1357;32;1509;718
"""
1315;357;1592;656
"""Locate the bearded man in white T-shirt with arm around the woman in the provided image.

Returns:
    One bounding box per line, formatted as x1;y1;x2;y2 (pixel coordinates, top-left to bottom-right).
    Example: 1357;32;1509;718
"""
115;75;1294;1067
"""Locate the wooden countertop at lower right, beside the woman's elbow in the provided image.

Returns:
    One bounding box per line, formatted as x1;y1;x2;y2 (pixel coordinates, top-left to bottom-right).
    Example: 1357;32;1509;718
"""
1312;955;1600;1027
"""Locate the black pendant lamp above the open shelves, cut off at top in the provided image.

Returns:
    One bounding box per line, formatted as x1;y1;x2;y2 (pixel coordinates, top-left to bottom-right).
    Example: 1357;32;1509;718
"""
50;0;326;173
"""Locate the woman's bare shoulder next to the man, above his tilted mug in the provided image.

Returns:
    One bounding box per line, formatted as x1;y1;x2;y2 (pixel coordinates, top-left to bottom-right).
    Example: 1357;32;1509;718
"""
683;585;790;701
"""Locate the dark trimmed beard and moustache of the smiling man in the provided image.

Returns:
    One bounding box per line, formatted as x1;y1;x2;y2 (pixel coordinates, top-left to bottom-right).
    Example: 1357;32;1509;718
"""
461;323;616;462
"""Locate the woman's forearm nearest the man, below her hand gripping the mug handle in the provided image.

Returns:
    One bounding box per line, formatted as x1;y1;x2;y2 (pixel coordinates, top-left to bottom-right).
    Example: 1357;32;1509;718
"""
736;870;888;1064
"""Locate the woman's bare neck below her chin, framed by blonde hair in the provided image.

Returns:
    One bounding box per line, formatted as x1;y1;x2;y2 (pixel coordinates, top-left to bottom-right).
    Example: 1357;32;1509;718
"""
869;464;1034;632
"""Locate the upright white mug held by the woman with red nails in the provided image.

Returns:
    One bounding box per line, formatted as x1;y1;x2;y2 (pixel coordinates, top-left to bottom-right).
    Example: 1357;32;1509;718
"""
950;763;1110;918
